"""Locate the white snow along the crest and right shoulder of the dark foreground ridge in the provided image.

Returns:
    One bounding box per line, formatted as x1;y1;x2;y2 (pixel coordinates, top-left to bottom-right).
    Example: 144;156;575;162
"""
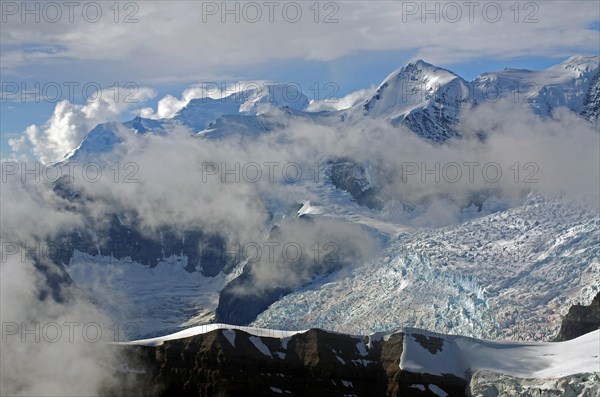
120;324;600;379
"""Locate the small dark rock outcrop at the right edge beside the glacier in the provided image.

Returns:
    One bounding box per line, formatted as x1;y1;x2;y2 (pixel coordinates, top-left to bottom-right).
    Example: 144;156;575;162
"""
555;293;600;342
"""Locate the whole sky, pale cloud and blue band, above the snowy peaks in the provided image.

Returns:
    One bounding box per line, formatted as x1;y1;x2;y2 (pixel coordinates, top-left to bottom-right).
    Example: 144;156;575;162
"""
0;1;600;157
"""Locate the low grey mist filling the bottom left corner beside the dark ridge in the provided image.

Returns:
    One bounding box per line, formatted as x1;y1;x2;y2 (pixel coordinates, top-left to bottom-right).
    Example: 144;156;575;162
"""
0;254;119;396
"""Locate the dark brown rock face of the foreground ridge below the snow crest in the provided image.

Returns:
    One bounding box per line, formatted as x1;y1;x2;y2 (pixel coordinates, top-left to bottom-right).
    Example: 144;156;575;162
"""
106;329;467;397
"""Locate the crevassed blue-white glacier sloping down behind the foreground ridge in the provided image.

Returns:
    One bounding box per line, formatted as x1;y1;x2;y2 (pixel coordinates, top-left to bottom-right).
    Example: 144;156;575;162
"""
252;196;600;340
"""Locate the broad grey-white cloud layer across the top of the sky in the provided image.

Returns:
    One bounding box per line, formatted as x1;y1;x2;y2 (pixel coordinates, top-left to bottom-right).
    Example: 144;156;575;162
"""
2;1;598;81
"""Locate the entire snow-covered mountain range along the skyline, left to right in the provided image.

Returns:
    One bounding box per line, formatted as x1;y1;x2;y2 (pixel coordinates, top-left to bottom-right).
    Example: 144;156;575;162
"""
66;56;600;160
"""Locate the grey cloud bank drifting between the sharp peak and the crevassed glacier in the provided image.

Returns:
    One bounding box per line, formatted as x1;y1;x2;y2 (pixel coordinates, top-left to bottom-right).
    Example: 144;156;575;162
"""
355;100;600;227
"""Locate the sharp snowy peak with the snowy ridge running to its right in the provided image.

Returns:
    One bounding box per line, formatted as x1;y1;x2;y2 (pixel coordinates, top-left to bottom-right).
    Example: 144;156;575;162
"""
341;56;600;142
